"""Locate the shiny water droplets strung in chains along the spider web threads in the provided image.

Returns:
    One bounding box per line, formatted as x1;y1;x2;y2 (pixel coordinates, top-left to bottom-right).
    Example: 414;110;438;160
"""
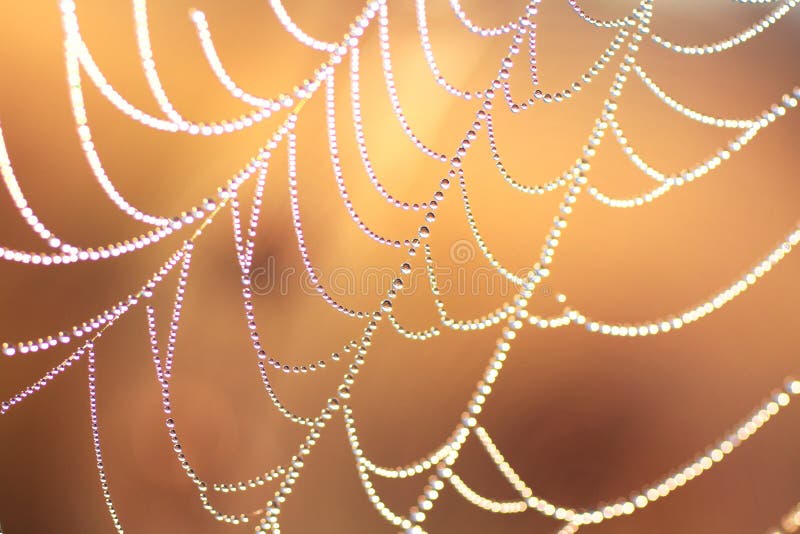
0;0;800;533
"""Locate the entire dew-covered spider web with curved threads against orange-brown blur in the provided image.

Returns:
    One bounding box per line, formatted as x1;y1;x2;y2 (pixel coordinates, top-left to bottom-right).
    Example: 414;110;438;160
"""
0;0;800;534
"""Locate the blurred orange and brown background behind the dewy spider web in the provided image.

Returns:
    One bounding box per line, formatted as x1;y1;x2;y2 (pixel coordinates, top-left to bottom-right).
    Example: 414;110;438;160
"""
0;0;800;534
